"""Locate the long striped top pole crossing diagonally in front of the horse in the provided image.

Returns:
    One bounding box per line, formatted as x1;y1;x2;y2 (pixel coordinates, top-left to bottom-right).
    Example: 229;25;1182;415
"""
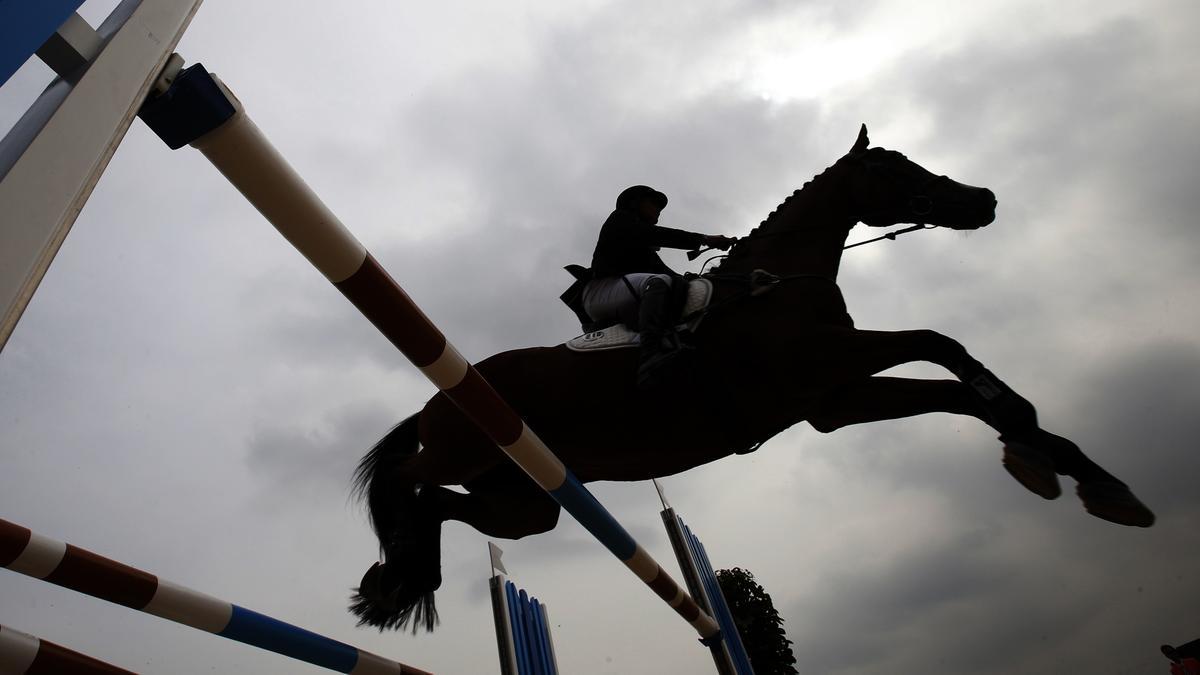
139;56;720;644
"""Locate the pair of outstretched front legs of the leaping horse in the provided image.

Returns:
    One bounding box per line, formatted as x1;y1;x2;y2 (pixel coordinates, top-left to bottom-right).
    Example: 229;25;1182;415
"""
810;329;1154;527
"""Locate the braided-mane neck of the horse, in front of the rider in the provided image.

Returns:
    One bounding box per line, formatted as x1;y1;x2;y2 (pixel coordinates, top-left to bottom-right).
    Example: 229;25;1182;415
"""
721;162;854;281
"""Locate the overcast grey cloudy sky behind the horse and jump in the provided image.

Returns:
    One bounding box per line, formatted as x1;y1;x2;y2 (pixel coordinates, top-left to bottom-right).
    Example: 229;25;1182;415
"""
0;0;1200;675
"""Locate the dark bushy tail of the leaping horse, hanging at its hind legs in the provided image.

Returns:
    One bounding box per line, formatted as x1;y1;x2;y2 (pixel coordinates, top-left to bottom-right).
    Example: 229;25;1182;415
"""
349;413;442;633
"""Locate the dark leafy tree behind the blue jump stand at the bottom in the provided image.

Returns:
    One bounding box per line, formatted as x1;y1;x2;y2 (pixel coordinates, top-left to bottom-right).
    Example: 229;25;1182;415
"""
716;567;797;675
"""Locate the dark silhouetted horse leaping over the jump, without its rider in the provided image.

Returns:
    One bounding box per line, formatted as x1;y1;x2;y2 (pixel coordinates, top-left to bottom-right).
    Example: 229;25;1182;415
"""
350;125;1154;633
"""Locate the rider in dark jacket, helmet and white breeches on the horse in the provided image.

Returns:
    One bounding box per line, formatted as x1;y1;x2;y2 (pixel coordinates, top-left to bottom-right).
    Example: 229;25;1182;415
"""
564;185;736;386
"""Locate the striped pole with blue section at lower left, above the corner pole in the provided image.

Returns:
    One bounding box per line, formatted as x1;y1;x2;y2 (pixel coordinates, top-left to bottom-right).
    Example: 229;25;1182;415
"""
0;519;430;675
